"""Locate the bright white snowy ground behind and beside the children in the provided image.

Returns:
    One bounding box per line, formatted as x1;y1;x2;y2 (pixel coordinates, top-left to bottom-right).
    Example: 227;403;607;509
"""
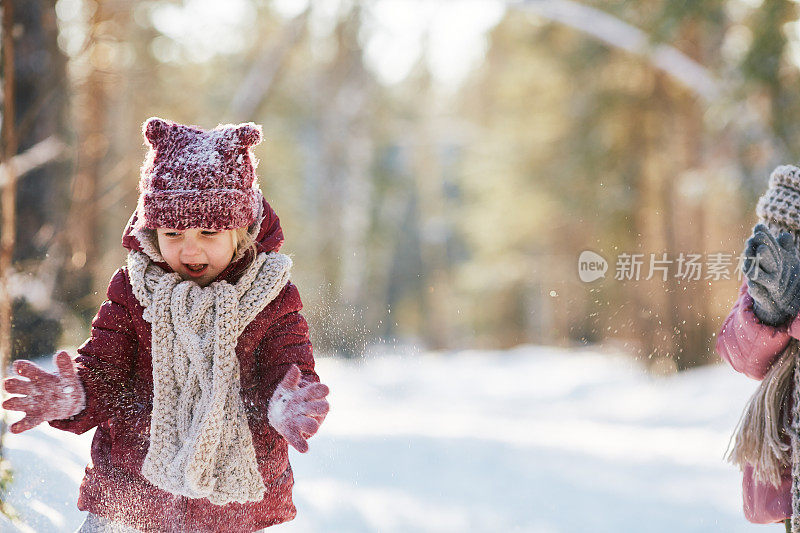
0;346;782;533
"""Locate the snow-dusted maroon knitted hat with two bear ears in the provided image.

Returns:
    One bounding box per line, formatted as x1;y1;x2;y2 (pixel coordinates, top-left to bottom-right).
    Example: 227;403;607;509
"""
136;117;262;230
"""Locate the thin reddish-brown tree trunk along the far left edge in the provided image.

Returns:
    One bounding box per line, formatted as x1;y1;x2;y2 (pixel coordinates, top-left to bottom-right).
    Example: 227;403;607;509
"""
0;0;17;458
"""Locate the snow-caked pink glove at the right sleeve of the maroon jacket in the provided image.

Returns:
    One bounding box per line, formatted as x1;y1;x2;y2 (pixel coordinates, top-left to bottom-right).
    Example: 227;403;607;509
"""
267;365;330;453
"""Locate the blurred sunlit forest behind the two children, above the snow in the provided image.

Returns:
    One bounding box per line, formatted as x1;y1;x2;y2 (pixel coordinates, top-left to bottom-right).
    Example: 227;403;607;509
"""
0;0;800;372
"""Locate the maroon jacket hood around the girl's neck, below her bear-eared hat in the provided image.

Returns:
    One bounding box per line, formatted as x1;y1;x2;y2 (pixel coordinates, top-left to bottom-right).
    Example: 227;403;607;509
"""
122;194;283;282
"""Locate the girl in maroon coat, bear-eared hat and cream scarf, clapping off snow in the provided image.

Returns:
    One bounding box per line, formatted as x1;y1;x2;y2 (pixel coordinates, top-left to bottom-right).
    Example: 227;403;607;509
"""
3;118;329;533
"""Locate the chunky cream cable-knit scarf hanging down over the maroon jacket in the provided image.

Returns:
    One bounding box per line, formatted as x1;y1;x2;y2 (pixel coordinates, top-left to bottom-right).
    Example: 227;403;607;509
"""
128;247;292;505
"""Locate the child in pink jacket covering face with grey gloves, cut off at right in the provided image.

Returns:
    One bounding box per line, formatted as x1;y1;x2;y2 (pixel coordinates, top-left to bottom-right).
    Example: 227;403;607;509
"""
716;165;800;532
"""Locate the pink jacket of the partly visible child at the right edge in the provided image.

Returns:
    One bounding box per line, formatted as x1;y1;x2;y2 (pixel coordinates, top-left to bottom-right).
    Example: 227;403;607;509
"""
716;281;800;524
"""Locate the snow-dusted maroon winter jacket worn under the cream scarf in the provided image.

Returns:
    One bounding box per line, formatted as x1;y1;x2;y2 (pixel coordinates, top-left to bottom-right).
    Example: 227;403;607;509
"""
50;193;319;533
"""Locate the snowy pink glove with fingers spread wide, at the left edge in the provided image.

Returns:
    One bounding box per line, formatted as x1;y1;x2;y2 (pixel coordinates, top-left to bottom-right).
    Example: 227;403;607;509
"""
3;352;86;433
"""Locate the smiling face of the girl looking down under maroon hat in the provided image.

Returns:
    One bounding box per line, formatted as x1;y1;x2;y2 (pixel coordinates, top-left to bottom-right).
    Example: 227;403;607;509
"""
157;228;236;287
